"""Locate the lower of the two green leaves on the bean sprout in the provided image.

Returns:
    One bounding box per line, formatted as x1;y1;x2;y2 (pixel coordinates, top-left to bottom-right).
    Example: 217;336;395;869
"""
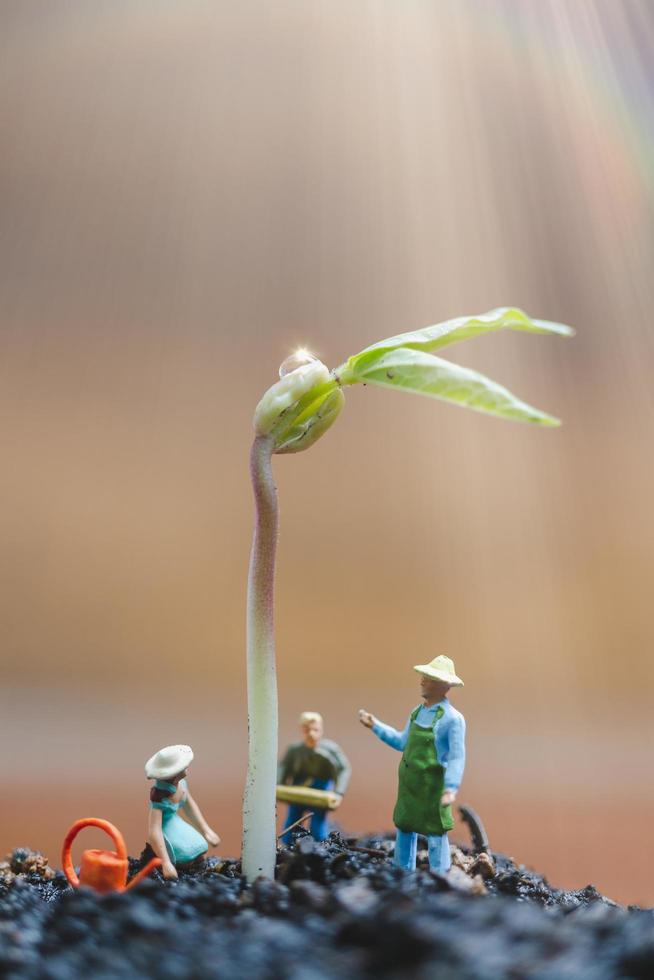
354;347;560;425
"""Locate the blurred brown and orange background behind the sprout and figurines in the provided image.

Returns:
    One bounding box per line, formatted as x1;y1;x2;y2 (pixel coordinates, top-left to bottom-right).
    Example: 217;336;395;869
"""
0;0;654;903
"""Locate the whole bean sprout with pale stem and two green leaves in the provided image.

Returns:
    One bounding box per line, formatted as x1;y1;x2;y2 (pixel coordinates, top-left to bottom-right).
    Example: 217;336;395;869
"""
243;307;573;881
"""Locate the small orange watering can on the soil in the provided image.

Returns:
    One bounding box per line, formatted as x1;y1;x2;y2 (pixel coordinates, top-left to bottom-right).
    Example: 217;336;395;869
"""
61;817;161;894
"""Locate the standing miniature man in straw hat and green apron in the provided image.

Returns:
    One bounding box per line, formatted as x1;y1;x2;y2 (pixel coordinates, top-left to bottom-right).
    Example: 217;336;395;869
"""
359;656;465;873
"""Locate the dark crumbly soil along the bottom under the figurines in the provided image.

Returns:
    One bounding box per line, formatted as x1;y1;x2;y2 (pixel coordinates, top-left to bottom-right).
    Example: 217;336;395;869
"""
0;833;654;980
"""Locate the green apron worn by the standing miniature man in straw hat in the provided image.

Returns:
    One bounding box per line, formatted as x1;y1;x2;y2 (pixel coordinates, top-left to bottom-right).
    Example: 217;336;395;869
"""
393;705;454;837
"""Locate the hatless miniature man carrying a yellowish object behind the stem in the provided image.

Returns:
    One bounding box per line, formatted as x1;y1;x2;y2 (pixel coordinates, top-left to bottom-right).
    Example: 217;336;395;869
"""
277;711;352;844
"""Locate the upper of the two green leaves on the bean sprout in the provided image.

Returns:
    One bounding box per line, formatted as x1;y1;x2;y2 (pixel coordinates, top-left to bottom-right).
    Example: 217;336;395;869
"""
334;307;574;384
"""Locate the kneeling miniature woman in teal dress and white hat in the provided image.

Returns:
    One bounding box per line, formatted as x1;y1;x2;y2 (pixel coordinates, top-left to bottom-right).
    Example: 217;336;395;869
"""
143;745;220;878
